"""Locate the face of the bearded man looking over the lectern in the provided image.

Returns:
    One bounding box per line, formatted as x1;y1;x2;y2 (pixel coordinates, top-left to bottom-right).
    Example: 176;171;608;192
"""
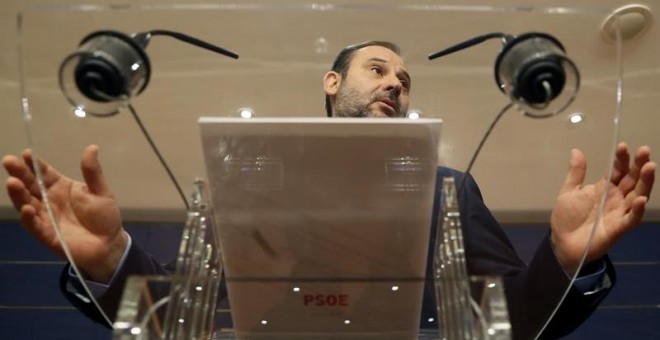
326;46;410;117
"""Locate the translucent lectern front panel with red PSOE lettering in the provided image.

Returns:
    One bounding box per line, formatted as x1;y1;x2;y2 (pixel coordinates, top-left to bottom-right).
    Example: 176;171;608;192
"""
201;117;441;339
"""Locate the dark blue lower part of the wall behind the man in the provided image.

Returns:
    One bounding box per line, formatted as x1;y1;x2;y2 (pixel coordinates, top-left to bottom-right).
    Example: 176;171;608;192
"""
0;221;660;340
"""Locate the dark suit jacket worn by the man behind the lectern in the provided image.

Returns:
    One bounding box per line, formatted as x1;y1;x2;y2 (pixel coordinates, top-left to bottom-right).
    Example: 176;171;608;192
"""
61;167;615;339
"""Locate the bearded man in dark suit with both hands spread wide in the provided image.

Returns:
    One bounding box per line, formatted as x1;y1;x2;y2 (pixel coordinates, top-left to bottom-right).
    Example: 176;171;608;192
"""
3;42;656;339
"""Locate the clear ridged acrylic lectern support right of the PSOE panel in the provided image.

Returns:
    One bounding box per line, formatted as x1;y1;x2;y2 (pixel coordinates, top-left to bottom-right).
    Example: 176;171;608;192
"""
433;177;511;340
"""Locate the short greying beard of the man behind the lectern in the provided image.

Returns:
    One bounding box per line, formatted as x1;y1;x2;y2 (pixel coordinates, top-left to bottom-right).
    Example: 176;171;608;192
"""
333;84;405;118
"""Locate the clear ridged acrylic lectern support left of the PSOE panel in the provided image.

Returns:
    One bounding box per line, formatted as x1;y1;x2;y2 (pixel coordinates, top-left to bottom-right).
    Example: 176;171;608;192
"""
113;180;222;340
